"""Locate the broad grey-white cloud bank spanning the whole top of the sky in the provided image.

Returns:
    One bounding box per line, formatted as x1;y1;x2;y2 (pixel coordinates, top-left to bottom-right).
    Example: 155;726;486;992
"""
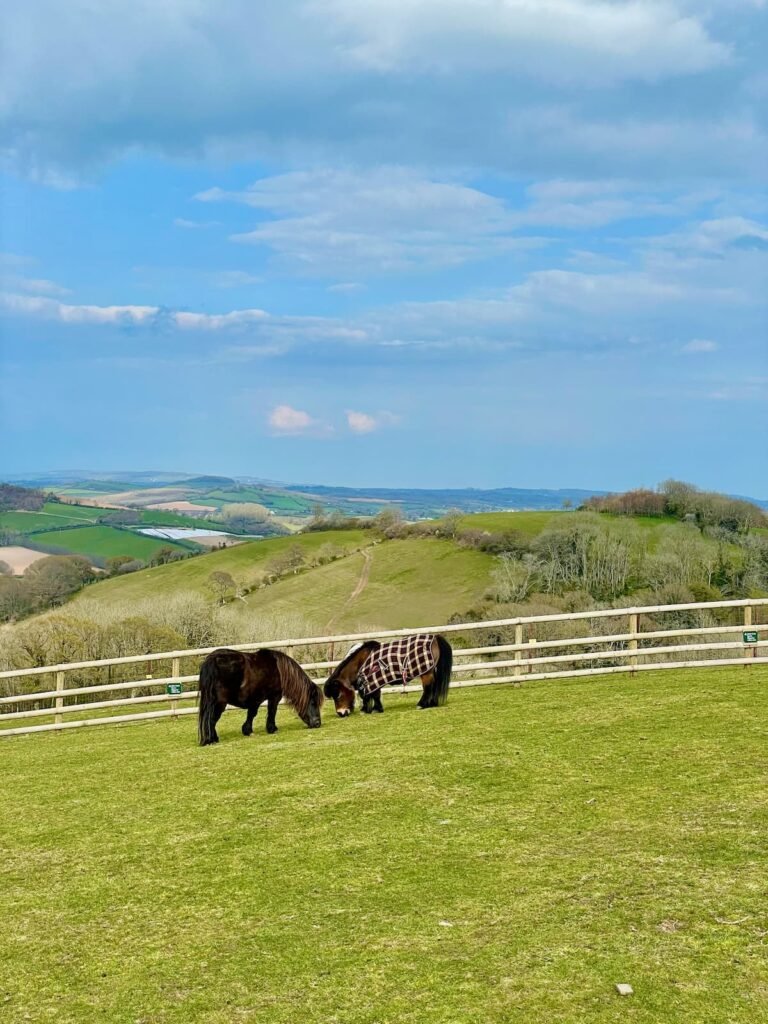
0;0;765;185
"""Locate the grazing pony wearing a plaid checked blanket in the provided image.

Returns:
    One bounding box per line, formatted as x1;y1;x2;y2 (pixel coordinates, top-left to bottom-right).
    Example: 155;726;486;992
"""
323;633;454;718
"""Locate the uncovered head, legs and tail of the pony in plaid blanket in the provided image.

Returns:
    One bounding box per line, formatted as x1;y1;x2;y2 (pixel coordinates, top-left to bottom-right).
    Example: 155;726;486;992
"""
323;634;454;718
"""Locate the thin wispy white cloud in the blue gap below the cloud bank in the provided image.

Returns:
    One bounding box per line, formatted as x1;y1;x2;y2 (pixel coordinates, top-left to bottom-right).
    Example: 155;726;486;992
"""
201;167;540;275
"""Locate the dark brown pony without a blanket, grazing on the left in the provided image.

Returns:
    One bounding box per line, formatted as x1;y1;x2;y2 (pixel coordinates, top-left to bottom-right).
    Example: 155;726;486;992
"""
198;647;323;746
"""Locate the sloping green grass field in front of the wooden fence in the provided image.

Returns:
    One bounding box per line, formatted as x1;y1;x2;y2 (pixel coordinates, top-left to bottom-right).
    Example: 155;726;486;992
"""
0;669;768;1024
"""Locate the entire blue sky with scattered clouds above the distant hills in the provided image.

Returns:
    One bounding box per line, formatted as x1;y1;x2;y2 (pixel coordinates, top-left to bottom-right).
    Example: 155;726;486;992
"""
0;0;768;497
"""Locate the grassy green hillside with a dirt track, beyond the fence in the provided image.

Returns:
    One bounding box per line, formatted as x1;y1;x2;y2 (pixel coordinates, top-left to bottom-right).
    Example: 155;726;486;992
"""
60;512;741;634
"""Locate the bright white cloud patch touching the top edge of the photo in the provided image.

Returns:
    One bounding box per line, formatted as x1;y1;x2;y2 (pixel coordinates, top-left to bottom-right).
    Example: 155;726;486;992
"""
324;0;730;81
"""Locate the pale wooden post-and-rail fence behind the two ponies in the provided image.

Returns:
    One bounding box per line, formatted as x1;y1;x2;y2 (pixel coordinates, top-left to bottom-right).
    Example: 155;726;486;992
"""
0;598;768;738
